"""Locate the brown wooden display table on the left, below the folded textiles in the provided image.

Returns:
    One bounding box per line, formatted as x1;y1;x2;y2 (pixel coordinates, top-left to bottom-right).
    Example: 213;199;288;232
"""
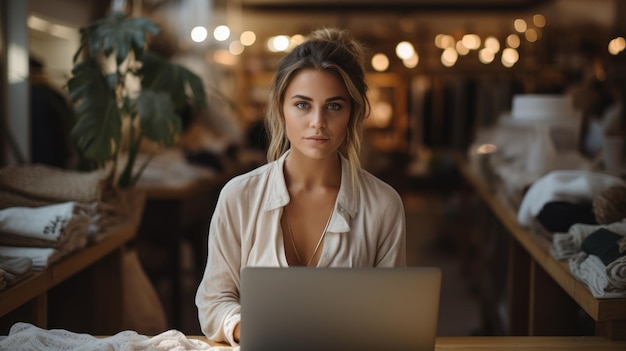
0;192;145;334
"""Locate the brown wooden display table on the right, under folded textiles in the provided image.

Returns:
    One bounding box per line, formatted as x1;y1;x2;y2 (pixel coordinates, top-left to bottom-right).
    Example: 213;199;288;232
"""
457;158;626;339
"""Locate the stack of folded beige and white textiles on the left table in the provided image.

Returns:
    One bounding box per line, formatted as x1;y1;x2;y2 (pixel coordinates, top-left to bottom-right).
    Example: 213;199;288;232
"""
0;165;128;290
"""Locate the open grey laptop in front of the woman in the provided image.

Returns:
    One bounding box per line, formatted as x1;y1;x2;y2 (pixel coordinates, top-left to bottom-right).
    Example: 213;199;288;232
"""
240;267;441;351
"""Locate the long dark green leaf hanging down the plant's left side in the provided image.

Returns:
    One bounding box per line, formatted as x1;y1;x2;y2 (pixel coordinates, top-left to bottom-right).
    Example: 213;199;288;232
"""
68;60;122;162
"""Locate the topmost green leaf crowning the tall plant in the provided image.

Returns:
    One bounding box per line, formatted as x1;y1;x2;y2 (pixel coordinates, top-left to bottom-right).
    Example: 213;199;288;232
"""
74;12;159;65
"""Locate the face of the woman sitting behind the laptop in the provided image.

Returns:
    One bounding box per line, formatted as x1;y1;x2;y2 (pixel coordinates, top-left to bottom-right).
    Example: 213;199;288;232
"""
283;69;351;159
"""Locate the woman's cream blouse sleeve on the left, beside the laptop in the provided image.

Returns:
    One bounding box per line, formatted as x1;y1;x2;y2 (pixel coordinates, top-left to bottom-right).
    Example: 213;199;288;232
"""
195;189;241;345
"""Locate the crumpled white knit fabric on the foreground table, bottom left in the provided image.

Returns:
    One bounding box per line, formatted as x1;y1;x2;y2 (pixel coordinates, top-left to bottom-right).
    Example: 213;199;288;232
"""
0;322;238;351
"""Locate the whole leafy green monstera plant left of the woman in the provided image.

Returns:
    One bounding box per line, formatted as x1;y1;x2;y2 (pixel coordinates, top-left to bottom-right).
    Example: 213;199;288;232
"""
68;11;206;188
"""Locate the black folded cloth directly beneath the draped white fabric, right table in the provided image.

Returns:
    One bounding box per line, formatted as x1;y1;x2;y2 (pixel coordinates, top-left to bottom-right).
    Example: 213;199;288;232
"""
535;201;598;233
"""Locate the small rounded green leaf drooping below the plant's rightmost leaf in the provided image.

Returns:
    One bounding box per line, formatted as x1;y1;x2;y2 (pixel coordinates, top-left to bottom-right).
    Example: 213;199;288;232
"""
137;89;182;146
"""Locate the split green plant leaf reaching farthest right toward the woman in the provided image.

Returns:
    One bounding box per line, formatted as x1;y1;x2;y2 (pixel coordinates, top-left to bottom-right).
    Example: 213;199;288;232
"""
138;51;207;111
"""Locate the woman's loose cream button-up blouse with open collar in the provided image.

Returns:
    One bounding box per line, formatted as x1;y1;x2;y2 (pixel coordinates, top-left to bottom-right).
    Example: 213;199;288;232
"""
196;152;406;345
